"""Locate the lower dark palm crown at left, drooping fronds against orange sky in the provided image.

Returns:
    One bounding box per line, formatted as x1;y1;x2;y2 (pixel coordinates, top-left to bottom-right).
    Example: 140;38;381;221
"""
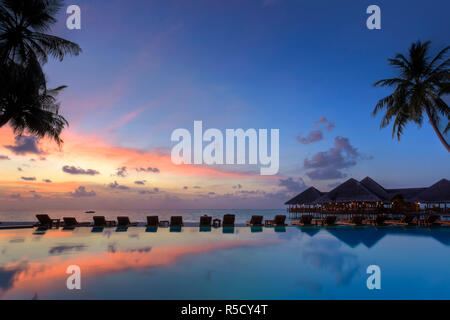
0;63;68;145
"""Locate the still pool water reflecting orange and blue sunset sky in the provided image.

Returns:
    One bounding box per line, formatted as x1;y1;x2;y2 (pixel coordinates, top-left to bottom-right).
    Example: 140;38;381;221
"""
0;227;450;299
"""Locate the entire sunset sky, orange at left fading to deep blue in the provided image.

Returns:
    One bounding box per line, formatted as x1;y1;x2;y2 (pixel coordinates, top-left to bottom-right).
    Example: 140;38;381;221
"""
0;0;450;210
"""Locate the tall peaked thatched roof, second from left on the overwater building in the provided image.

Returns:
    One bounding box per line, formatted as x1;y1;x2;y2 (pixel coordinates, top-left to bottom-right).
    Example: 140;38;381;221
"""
316;179;383;203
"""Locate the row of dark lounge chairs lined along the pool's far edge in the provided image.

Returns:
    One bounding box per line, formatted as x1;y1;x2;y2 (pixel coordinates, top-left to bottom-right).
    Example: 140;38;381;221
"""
36;214;446;228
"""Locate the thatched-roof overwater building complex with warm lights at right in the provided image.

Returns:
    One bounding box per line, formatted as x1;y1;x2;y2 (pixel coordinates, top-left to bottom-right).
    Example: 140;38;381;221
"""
286;177;450;218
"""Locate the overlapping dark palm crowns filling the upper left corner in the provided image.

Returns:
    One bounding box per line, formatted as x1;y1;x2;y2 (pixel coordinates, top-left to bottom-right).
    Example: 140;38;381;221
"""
0;0;81;144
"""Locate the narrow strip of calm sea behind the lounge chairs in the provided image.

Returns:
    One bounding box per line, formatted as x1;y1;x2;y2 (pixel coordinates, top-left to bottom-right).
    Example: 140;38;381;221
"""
0;209;286;224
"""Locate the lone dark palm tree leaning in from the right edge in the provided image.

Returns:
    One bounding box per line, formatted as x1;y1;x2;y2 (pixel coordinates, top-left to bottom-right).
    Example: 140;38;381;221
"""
373;41;450;152
